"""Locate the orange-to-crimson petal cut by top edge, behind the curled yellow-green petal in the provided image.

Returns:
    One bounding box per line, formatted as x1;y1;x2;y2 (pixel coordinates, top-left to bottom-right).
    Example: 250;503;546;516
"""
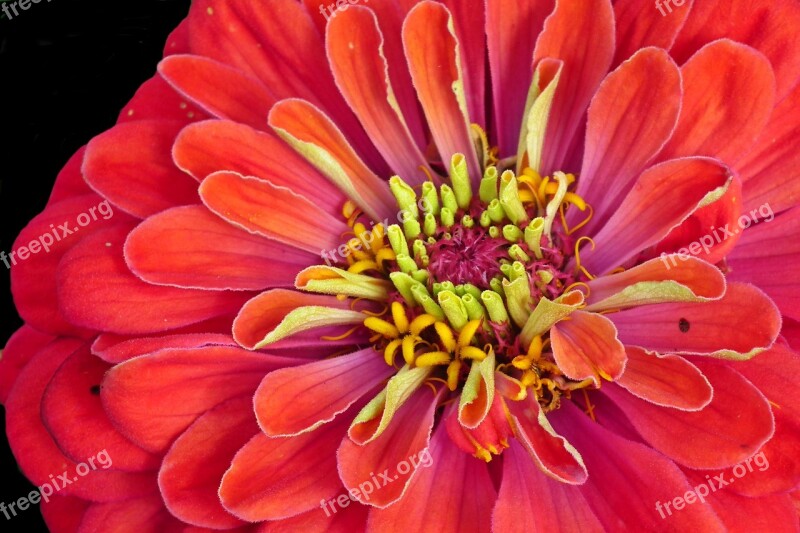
486;0;555;157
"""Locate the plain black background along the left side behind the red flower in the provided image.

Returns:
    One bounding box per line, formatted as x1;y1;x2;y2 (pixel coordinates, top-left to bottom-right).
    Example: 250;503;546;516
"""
0;0;190;531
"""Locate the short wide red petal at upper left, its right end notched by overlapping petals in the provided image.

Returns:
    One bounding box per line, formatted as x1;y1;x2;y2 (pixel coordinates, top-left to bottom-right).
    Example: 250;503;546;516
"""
83;120;198;218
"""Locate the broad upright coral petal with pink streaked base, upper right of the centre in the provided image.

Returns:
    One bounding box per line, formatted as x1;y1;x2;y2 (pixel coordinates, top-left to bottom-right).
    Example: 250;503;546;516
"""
576;47;682;233
